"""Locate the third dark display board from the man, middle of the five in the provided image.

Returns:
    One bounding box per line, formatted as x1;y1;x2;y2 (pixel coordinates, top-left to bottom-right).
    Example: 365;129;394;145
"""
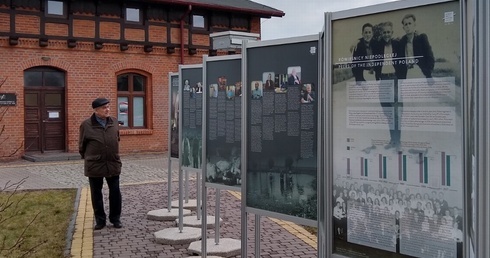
203;55;242;190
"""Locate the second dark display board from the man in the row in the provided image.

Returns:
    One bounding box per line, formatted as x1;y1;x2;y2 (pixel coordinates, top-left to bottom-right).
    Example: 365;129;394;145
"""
179;64;203;171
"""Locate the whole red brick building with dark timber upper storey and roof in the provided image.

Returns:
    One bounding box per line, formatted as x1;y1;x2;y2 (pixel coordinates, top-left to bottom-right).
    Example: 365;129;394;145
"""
0;0;284;159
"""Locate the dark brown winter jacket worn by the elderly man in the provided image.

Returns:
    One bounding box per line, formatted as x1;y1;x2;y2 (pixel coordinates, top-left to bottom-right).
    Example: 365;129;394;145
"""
78;114;122;177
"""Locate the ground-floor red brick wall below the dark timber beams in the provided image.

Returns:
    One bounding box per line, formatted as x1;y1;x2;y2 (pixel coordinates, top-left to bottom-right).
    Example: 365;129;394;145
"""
0;38;195;158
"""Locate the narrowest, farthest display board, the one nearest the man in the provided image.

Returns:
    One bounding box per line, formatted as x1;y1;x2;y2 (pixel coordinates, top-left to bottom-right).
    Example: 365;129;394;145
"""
168;73;180;158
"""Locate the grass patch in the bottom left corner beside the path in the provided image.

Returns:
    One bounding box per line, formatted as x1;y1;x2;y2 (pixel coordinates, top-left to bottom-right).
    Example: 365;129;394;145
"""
0;189;77;257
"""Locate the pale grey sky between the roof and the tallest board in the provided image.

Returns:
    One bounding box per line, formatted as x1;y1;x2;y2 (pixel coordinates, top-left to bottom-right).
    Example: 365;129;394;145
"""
252;0;396;40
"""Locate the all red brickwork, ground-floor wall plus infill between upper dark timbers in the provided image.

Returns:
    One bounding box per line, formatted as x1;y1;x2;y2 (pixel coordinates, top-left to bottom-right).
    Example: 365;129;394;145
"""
0;7;260;160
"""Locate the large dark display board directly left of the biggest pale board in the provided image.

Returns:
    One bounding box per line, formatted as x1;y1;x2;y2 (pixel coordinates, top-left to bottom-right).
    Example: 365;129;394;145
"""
243;35;319;224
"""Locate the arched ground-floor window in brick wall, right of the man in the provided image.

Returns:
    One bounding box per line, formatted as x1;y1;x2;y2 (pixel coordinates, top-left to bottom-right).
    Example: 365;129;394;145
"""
115;73;148;128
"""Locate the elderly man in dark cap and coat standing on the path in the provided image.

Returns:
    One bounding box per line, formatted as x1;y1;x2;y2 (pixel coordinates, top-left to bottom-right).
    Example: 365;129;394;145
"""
79;98;122;230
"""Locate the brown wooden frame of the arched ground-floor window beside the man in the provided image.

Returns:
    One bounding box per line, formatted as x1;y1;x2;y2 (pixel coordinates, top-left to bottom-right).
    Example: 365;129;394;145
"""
114;70;152;130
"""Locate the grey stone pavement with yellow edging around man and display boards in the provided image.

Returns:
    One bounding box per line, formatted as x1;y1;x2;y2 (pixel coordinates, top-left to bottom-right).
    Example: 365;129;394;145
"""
0;154;317;258
